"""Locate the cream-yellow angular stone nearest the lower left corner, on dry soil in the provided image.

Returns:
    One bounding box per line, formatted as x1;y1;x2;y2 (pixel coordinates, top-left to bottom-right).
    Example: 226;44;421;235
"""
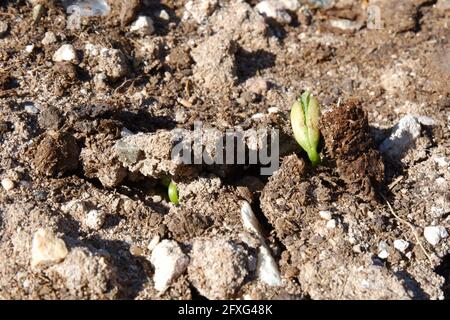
31;228;68;267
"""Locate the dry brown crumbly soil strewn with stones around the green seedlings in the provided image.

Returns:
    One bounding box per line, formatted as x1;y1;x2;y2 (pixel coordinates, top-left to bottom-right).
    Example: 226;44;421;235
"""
0;0;450;300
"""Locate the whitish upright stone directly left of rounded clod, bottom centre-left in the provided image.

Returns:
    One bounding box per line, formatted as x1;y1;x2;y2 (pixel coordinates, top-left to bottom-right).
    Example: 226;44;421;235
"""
150;240;189;292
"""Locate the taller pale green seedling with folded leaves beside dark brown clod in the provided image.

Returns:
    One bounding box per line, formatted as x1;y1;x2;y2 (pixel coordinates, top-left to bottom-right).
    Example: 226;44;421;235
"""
291;91;320;166
